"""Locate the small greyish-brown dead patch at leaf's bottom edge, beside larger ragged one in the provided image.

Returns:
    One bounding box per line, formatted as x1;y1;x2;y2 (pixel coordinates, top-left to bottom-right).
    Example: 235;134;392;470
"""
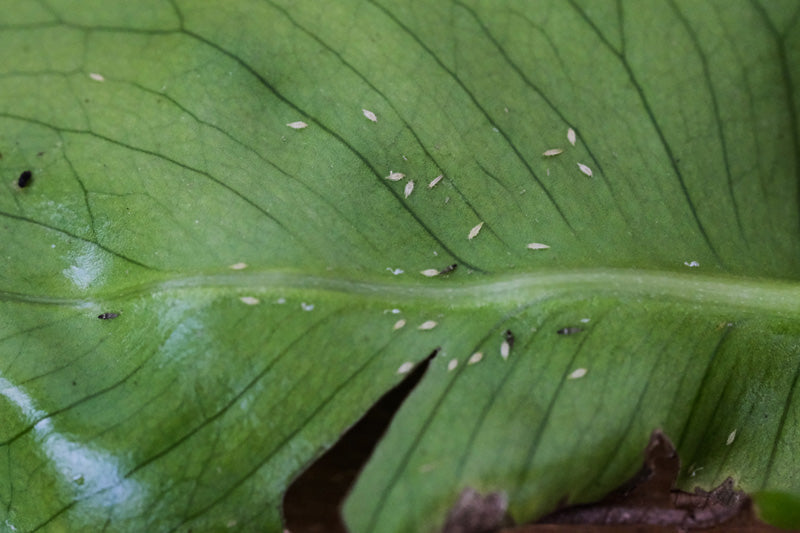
442;487;513;533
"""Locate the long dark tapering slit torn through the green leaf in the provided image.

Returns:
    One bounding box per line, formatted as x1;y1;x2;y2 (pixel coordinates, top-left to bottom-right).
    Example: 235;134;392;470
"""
283;351;437;533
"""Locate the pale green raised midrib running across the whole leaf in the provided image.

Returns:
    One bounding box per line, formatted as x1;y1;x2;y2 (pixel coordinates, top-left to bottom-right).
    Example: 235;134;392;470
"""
6;269;800;318
